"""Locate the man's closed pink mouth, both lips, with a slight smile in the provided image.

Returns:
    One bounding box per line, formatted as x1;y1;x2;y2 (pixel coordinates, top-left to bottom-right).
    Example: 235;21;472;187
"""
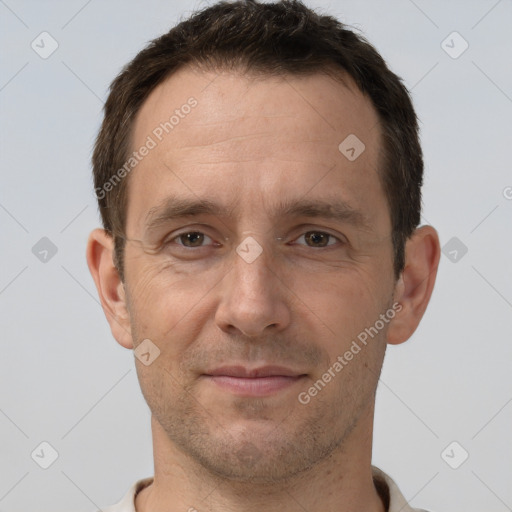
203;366;306;397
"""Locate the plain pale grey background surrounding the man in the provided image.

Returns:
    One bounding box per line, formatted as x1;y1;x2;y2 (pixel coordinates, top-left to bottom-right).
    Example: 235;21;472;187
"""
0;0;512;512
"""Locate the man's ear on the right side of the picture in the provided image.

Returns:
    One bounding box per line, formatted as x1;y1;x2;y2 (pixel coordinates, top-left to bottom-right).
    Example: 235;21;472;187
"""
387;226;441;345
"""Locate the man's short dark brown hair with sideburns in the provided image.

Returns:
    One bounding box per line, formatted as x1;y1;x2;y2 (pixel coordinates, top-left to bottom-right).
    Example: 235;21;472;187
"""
92;0;423;279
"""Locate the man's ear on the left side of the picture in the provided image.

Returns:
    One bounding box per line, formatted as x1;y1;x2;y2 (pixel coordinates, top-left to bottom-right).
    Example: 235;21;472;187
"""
87;229;133;348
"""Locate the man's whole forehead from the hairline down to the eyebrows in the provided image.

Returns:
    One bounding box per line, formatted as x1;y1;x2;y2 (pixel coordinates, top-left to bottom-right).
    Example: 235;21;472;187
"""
128;63;383;235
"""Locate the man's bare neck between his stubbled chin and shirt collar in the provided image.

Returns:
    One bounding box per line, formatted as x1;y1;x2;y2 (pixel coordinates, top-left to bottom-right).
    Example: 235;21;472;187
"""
135;407;385;512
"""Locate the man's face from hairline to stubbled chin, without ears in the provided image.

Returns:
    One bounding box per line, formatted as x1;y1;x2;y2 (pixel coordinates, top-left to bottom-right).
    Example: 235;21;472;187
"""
120;68;395;481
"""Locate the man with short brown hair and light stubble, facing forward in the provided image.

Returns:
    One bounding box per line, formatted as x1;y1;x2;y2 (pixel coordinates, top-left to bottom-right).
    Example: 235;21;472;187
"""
87;0;439;512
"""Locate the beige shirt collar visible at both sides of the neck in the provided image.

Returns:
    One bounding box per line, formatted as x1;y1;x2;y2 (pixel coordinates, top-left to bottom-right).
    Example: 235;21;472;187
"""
98;466;427;512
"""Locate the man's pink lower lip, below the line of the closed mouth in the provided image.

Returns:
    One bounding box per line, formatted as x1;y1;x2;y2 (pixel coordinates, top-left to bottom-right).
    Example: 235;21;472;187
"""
206;375;305;396
